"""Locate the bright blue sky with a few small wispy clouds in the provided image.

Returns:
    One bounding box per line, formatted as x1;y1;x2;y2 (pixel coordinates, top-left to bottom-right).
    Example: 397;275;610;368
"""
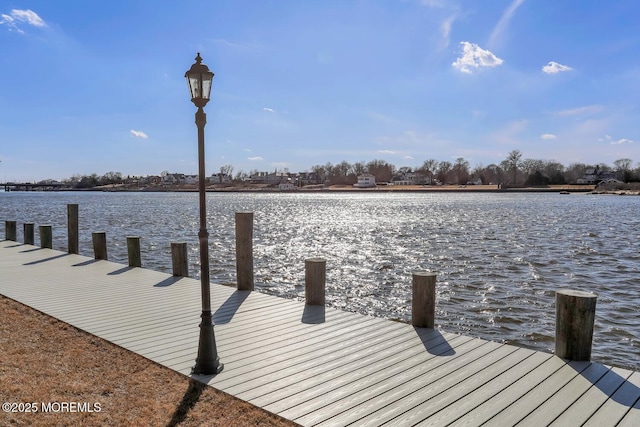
0;0;640;181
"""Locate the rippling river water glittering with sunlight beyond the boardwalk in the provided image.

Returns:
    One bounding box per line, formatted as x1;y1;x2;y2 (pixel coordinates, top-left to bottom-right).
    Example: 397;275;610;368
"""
0;192;640;370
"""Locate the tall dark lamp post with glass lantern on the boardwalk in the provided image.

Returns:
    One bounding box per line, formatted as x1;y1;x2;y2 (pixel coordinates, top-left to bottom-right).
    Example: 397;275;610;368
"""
184;53;224;375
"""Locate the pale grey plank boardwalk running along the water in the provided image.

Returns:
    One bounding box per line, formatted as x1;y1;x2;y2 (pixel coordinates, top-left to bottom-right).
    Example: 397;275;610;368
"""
0;240;640;427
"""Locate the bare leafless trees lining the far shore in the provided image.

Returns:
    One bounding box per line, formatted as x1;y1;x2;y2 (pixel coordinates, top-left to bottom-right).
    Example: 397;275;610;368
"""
63;150;640;188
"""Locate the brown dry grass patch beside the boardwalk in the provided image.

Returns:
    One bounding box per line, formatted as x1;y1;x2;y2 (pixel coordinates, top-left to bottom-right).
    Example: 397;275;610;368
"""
0;295;296;426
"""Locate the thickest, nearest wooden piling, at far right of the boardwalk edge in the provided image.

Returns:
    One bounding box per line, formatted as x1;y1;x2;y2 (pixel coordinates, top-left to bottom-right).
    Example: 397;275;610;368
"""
556;289;598;361
